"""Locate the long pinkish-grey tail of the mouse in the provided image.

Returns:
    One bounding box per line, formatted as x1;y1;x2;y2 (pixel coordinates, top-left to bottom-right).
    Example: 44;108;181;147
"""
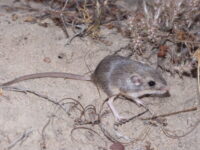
0;72;91;86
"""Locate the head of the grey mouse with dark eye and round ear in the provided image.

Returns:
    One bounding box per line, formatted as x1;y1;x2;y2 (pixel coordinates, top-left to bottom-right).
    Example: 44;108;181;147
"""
129;68;169;97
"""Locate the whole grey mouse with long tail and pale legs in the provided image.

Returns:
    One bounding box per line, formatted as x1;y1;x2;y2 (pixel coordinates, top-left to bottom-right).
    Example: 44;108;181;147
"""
0;55;168;122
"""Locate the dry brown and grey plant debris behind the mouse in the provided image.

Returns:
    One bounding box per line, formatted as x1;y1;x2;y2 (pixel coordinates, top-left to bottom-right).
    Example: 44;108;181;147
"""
2;0;200;77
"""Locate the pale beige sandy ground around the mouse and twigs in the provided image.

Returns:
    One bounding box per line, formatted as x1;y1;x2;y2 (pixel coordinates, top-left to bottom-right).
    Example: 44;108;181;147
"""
0;0;200;150
